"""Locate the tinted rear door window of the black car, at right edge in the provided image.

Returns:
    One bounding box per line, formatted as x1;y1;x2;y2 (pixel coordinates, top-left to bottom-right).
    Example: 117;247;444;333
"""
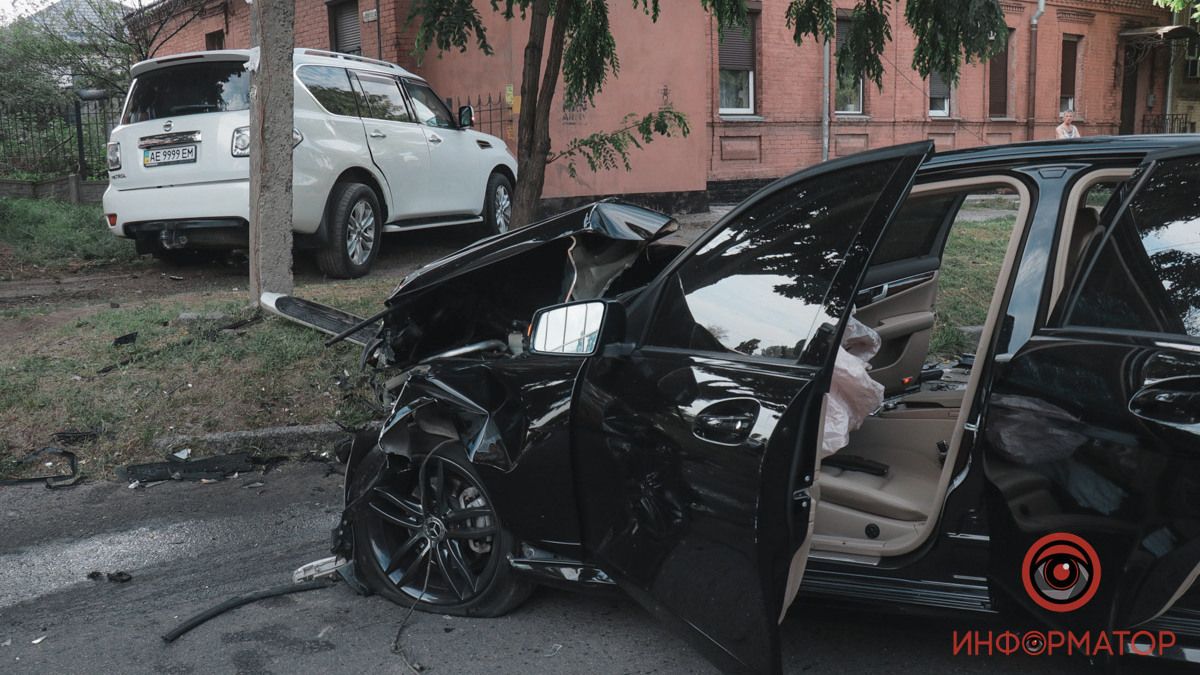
1068;157;1200;338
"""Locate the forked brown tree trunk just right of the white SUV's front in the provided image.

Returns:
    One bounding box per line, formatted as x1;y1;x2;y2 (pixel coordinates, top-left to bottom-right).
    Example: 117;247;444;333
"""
512;0;574;226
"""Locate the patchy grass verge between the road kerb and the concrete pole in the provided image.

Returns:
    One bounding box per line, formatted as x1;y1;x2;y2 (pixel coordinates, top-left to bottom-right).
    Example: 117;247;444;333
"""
0;279;394;477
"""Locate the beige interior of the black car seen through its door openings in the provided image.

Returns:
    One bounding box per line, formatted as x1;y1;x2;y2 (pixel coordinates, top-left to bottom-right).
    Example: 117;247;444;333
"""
811;169;1130;562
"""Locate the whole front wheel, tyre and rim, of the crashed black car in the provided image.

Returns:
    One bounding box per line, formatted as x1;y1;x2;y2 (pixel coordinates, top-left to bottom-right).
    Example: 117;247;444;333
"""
354;447;530;616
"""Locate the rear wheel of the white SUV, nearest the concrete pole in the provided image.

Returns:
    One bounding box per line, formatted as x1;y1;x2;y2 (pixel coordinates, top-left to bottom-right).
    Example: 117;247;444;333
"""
317;183;383;279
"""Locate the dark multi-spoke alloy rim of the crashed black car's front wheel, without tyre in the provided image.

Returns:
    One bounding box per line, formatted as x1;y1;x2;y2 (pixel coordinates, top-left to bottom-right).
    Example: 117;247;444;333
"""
368;454;503;598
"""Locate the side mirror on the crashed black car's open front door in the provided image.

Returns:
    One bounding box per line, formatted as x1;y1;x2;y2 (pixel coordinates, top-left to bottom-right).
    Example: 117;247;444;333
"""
529;300;625;357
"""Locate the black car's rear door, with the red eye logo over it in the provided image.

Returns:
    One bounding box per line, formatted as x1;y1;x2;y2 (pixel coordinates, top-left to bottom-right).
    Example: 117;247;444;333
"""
977;145;1200;629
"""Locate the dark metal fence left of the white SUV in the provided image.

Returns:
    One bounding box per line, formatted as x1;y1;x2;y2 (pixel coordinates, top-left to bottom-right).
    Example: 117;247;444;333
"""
0;98;121;179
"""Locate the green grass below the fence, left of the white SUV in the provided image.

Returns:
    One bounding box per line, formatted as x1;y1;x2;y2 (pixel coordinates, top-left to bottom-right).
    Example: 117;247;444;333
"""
0;198;138;271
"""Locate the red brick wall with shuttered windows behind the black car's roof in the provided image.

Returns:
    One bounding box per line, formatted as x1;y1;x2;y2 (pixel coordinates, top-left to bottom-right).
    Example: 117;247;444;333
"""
707;0;1169;181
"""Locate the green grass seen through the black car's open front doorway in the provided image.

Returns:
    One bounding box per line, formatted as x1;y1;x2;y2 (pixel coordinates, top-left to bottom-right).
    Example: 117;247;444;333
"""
930;217;1013;358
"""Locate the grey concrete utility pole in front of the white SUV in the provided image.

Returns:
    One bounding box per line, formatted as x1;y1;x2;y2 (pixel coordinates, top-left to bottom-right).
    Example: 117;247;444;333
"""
250;0;295;299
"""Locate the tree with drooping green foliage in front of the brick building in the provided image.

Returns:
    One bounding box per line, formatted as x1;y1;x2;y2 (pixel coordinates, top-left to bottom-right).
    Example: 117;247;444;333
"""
409;0;1012;223
